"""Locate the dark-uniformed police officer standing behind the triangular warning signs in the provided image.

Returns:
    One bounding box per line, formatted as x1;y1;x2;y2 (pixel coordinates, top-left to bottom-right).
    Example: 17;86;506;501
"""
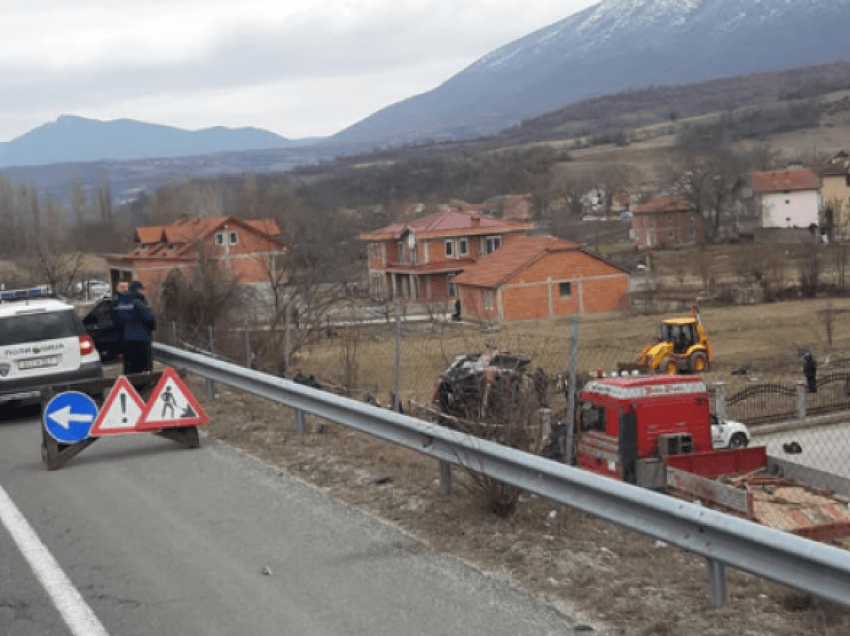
109;281;156;375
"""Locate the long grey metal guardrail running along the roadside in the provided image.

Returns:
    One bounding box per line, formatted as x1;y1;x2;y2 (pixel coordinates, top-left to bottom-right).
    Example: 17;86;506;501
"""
153;343;850;607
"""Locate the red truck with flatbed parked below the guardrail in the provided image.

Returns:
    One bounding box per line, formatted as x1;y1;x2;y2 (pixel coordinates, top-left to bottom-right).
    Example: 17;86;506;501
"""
576;375;850;547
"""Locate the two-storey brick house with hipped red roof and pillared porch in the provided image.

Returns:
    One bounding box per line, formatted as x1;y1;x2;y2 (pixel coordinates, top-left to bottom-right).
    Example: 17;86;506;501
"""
360;205;534;302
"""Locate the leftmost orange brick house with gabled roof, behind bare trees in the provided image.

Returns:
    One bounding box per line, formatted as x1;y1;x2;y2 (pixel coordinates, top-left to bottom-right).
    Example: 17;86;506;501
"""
108;216;286;299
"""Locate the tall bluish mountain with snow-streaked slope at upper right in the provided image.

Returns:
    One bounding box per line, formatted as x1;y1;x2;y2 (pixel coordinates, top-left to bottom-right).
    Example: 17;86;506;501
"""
331;0;850;145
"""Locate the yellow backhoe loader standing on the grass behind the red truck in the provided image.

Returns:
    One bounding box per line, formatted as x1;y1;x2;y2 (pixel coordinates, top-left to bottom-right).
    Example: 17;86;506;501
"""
634;307;711;375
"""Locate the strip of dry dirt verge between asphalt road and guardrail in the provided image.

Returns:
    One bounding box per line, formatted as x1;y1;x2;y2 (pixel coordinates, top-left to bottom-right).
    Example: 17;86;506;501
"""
190;379;850;636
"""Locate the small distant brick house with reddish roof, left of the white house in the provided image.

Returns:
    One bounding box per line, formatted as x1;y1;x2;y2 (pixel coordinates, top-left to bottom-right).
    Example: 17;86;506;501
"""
632;196;703;247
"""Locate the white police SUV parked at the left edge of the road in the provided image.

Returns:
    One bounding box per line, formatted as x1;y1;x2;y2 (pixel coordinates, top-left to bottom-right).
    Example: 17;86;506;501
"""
0;287;103;404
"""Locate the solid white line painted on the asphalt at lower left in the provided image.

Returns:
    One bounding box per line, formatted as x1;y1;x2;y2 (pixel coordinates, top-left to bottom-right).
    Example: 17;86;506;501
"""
0;486;109;636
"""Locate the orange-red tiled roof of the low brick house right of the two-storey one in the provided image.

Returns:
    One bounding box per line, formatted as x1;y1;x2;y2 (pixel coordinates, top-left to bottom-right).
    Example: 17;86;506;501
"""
453;236;594;288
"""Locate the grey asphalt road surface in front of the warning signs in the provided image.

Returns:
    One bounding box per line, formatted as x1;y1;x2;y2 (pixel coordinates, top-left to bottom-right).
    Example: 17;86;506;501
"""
0;414;587;636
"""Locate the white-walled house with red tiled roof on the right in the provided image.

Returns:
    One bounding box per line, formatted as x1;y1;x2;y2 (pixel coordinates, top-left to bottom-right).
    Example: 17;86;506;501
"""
750;168;823;229
